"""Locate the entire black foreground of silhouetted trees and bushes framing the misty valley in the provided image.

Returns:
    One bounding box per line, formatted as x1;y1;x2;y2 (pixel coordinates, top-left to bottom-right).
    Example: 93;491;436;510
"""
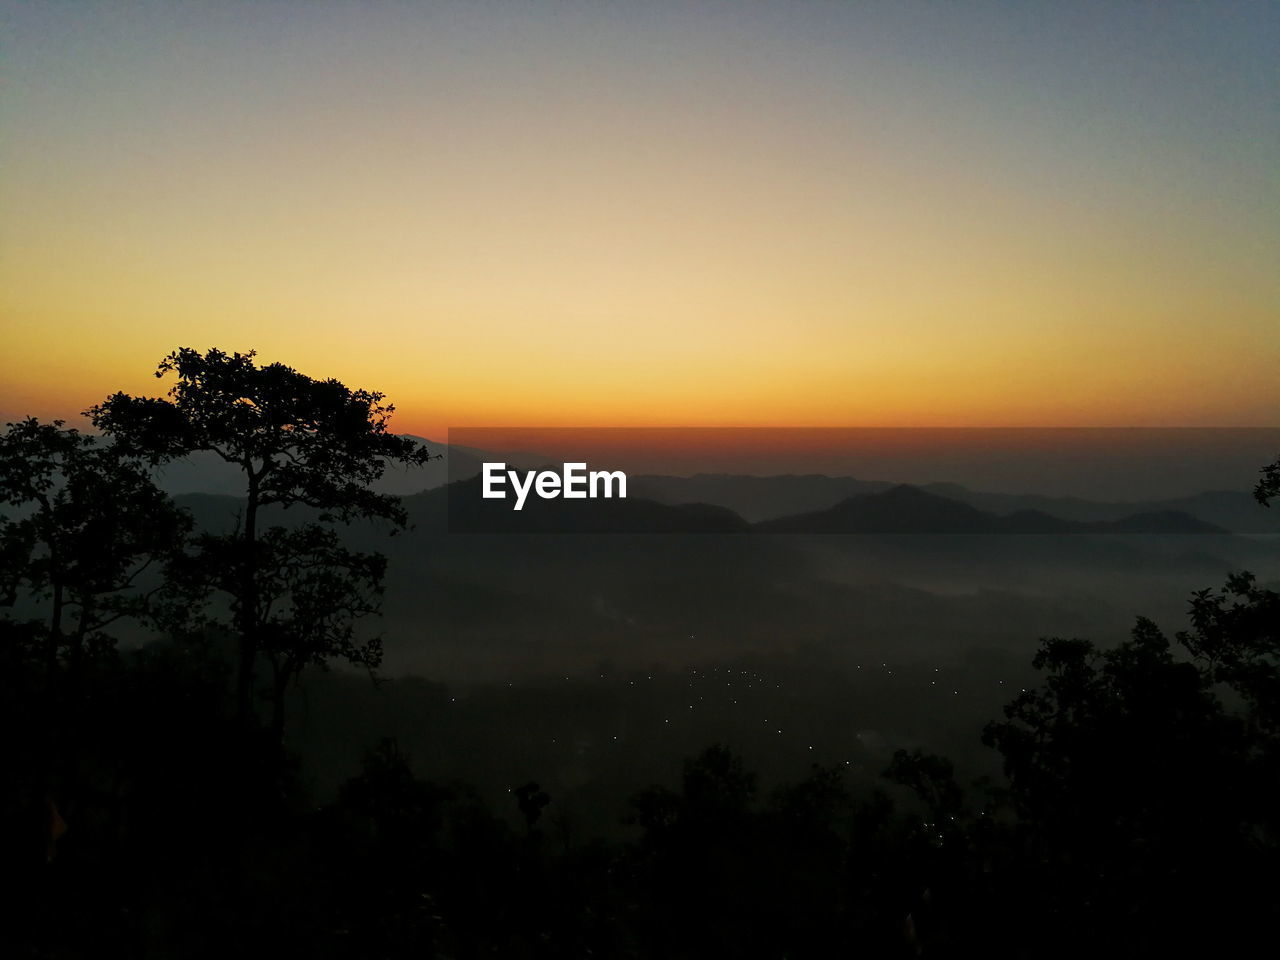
0;351;1280;957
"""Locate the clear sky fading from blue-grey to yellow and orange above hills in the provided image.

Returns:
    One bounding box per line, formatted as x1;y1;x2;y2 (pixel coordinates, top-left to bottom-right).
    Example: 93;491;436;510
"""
0;0;1280;435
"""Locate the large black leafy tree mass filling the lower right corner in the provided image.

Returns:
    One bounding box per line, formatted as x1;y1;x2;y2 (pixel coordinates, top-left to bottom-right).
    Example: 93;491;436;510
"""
983;601;1280;952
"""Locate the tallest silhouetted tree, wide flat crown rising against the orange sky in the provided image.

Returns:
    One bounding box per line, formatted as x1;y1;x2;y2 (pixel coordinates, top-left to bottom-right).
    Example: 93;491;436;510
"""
90;348;430;719
